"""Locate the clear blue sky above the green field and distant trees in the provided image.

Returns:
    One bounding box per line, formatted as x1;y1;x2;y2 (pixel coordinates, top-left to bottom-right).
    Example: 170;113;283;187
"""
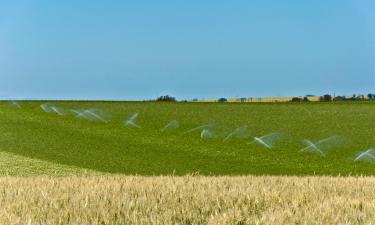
0;0;375;100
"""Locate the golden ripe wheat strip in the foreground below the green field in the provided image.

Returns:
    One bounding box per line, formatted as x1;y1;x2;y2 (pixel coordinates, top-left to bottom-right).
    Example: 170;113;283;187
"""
0;176;375;225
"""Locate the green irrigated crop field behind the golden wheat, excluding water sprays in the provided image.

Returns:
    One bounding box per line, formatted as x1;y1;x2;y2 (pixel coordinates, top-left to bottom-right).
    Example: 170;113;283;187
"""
0;102;375;175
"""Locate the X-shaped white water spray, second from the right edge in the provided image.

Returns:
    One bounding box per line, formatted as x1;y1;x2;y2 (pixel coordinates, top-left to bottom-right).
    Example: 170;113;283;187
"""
300;136;339;156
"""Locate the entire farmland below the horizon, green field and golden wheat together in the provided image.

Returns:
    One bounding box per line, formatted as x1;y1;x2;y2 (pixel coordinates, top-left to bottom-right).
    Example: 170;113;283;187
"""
0;101;375;225
